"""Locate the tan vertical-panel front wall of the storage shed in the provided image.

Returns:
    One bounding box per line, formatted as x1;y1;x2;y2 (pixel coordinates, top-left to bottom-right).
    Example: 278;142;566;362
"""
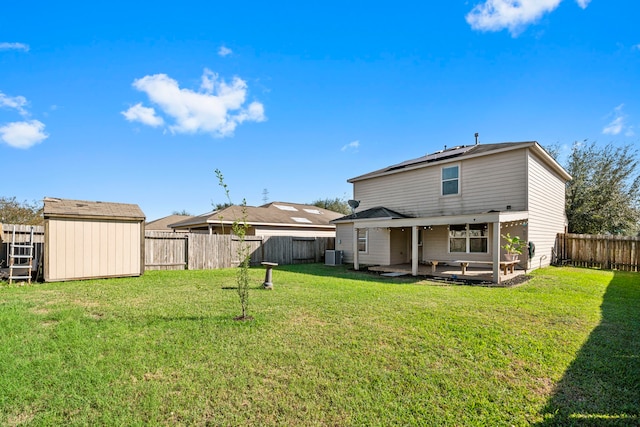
45;219;141;281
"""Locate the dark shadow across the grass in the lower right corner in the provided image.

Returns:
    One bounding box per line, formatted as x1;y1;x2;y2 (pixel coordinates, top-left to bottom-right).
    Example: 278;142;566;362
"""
536;273;640;427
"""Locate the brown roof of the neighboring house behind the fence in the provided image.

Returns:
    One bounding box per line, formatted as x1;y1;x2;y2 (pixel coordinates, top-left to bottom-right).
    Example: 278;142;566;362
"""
171;202;342;228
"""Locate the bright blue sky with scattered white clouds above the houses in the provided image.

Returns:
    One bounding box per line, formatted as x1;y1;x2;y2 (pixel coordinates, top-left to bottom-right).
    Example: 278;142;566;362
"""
0;0;640;220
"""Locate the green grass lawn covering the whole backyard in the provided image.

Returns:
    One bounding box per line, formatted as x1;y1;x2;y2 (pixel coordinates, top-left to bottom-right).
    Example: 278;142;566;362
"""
0;264;640;426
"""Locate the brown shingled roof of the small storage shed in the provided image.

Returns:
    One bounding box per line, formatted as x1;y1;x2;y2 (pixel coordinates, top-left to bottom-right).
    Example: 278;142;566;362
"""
44;197;145;221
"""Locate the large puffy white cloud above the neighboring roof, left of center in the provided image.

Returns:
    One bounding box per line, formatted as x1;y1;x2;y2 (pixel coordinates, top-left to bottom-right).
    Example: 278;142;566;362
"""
123;69;266;137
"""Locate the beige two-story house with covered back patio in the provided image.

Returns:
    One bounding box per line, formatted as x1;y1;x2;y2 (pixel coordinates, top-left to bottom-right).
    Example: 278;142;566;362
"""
332;142;571;282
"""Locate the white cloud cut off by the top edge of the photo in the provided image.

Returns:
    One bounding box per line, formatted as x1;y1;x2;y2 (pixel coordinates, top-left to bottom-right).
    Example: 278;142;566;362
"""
465;0;591;36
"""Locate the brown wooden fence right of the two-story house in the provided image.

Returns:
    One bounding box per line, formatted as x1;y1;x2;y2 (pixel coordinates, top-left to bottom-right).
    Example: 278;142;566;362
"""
554;234;640;271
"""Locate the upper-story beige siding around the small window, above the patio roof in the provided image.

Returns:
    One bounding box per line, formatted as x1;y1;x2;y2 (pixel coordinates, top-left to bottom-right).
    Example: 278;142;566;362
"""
354;149;527;217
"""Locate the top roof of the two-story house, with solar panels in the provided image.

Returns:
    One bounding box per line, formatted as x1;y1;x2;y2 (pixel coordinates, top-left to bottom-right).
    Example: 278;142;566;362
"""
347;141;571;183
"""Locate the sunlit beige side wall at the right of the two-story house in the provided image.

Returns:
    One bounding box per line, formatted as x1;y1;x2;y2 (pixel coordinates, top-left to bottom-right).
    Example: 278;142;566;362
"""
528;153;565;269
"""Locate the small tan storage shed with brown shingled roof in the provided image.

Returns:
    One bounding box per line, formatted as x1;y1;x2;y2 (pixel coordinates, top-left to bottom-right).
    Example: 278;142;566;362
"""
44;197;145;282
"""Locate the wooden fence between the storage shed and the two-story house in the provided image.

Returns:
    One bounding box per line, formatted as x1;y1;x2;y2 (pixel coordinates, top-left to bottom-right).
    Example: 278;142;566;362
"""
145;231;335;270
